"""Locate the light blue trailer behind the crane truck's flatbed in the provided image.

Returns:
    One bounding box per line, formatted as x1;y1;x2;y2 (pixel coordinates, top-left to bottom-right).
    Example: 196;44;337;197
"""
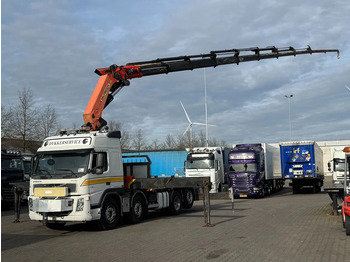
123;150;187;177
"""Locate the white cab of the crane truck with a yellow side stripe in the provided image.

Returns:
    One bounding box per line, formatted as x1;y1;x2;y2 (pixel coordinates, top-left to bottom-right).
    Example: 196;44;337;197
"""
29;131;124;226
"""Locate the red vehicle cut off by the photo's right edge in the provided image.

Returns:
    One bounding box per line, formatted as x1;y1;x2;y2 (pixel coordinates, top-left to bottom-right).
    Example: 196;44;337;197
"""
342;147;350;236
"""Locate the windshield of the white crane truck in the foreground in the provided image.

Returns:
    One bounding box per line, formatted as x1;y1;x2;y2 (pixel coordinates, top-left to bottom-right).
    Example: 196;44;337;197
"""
33;151;90;179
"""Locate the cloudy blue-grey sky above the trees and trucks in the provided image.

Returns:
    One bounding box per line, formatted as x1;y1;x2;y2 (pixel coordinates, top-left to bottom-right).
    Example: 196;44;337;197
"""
1;0;350;144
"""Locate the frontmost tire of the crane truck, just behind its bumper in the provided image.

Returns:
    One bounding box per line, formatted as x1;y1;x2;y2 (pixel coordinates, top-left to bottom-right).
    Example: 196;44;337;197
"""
97;198;120;230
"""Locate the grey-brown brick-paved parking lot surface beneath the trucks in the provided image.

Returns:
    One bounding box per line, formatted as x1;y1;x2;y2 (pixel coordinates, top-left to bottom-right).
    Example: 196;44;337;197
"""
1;189;350;262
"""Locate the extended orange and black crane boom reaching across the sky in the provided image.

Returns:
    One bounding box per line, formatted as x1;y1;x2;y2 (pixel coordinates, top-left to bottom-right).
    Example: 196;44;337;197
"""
84;46;339;130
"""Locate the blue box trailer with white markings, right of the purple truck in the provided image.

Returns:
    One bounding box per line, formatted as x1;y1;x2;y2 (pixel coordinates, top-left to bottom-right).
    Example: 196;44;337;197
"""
280;141;324;193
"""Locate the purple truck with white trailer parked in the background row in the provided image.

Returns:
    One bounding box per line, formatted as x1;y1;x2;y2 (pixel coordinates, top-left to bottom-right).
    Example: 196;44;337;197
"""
228;143;284;197
